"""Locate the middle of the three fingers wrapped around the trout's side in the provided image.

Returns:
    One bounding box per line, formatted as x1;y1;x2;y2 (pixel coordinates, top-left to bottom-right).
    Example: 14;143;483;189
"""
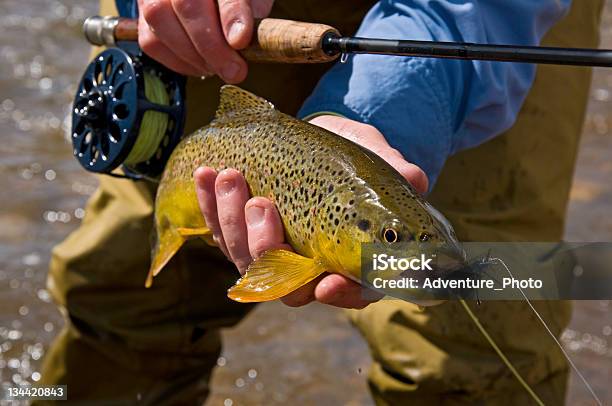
215;169;252;273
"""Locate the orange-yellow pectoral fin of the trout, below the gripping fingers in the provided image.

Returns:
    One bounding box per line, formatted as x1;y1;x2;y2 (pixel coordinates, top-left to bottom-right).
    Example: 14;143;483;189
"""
227;249;326;303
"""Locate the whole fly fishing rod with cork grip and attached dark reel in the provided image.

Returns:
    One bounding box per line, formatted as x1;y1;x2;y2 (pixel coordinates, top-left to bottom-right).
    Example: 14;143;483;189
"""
71;16;612;179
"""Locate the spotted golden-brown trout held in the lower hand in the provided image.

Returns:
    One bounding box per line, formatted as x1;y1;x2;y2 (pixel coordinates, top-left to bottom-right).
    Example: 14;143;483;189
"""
147;85;464;302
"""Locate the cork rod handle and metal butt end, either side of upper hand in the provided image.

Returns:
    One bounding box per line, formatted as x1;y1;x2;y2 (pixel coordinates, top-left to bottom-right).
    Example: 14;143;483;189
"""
83;16;340;63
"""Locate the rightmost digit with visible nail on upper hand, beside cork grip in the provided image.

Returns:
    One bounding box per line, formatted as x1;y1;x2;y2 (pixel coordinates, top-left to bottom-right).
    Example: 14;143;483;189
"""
219;0;253;49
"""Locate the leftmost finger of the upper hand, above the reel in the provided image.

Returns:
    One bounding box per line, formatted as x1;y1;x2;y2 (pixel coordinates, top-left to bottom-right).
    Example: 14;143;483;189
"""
141;0;212;76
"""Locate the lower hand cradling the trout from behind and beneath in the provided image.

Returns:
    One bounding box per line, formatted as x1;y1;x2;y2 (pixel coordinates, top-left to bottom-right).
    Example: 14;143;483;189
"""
194;116;427;309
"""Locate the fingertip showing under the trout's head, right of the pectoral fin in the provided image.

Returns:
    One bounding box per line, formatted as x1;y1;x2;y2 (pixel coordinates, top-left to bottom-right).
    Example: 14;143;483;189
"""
314;274;384;309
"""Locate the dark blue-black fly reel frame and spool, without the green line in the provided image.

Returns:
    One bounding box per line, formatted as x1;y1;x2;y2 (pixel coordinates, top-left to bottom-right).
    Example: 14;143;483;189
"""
71;42;185;180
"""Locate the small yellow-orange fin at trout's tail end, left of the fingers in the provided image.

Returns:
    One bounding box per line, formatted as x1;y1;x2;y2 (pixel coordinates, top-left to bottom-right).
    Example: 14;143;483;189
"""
145;226;210;288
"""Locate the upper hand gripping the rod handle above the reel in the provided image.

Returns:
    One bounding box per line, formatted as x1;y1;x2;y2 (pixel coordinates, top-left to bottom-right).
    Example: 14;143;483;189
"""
138;0;274;83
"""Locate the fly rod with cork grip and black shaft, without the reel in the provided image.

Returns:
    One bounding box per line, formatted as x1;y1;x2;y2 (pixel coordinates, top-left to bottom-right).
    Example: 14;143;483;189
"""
84;17;612;67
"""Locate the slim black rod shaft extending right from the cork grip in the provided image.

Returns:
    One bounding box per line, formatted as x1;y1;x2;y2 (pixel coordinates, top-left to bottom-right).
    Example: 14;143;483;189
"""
323;34;612;67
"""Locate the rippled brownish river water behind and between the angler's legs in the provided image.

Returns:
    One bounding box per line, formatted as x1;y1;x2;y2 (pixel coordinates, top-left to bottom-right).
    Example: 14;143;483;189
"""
0;0;612;405
